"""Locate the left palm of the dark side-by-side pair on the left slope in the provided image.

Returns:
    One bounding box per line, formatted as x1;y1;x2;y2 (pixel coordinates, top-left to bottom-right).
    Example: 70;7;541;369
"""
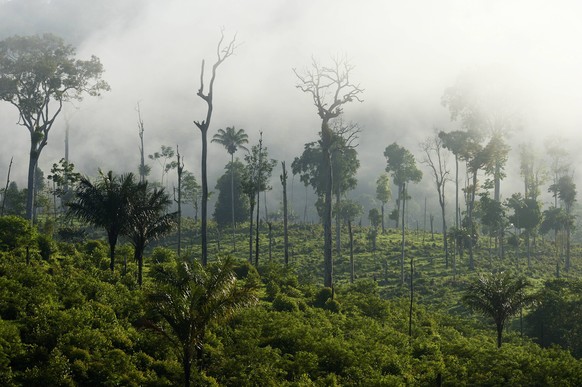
68;171;136;271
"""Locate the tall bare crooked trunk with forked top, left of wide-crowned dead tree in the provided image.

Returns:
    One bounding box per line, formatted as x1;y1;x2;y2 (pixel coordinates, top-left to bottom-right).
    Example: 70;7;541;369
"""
194;30;236;266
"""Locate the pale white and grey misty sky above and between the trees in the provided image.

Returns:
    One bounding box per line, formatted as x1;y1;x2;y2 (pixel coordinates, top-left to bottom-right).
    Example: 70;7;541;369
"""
0;0;582;223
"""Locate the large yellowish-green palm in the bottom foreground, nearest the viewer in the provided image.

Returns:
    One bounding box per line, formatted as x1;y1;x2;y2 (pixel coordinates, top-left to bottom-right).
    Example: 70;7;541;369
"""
148;259;257;387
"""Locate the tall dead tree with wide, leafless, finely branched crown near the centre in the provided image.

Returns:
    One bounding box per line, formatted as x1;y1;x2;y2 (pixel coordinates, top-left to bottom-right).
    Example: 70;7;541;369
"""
293;58;363;287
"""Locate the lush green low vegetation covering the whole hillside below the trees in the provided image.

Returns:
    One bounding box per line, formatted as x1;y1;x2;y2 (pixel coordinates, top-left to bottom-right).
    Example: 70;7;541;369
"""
0;217;582;386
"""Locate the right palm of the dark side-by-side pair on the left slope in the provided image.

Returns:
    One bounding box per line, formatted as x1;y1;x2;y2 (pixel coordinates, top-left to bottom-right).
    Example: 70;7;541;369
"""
123;181;178;286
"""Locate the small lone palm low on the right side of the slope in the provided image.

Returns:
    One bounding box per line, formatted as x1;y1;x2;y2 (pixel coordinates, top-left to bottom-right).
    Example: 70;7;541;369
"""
463;272;533;348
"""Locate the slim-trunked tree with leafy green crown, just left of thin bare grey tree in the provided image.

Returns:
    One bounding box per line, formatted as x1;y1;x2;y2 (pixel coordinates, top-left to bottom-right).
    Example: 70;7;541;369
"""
384;143;422;284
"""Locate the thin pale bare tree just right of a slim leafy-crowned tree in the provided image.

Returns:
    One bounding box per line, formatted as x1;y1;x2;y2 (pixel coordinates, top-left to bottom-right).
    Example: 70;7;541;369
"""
421;134;450;268
